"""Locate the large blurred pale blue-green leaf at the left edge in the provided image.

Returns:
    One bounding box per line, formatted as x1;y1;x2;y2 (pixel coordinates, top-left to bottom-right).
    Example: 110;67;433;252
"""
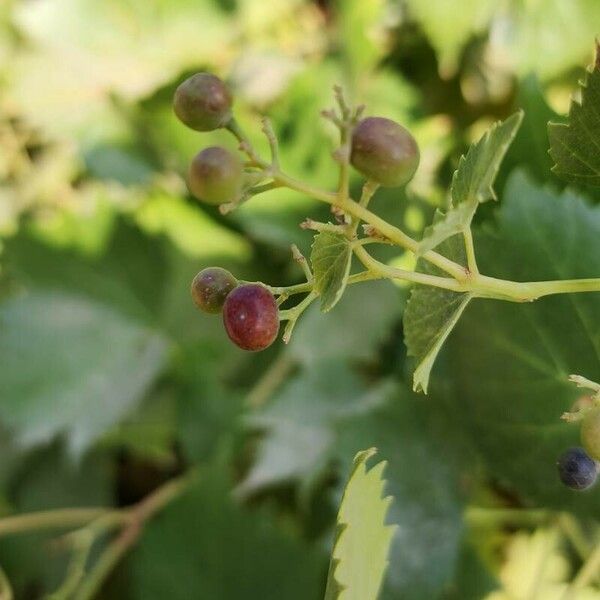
0;289;167;453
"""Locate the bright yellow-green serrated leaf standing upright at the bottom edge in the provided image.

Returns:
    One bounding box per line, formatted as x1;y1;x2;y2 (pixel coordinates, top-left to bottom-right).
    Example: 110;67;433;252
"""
325;448;395;600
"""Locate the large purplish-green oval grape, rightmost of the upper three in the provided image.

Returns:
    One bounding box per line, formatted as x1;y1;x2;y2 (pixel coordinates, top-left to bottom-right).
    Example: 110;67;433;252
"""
350;117;420;187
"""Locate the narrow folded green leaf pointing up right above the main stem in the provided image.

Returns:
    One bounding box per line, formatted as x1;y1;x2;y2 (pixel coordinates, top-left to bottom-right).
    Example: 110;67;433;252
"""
418;111;523;254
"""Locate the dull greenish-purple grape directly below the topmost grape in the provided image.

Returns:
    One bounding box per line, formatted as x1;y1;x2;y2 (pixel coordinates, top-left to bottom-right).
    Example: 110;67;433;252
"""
188;146;244;204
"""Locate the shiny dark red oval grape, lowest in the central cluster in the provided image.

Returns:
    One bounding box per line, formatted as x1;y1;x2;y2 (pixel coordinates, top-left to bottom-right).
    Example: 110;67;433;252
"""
223;283;279;352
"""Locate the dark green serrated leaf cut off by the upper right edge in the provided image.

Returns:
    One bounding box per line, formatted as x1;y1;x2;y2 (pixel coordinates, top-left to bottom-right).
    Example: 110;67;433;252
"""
548;45;600;186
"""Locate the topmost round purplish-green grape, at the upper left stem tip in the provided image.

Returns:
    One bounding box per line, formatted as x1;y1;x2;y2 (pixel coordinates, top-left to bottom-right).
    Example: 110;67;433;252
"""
173;73;231;131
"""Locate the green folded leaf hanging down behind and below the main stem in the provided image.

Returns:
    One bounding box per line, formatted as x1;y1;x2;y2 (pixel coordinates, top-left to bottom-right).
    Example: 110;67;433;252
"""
404;212;472;393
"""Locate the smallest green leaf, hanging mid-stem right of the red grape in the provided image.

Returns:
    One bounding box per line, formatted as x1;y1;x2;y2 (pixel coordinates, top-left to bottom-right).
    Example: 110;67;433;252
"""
310;231;352;312
